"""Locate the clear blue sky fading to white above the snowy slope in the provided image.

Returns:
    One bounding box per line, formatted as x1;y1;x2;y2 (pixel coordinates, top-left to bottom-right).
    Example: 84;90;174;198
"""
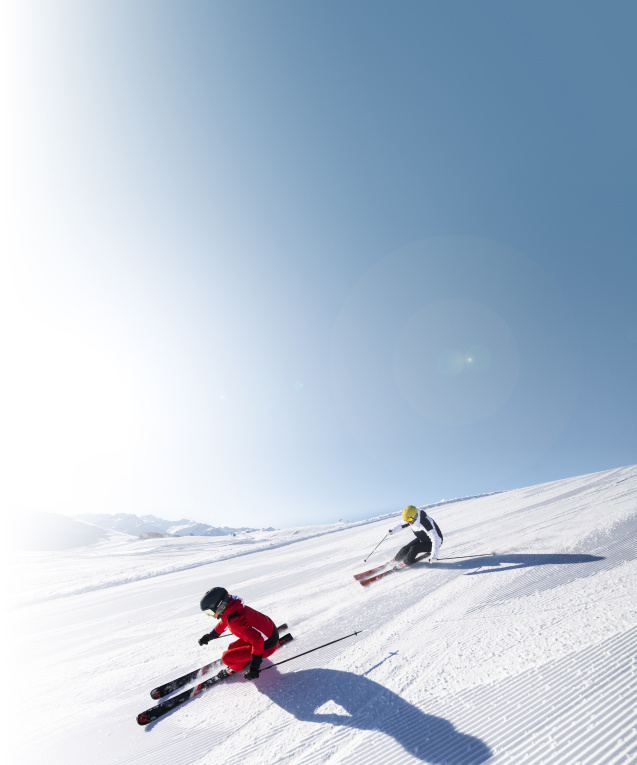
0;0;637;526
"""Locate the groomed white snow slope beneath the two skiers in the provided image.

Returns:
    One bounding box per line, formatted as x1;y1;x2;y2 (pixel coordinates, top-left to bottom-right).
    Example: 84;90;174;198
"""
8;466;637;765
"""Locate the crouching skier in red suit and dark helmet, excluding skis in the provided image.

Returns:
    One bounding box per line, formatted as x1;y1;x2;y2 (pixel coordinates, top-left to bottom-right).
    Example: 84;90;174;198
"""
199;587;279;680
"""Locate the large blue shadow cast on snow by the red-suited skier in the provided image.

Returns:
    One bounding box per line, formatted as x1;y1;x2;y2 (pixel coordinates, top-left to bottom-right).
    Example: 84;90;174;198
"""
257;668;493;765
